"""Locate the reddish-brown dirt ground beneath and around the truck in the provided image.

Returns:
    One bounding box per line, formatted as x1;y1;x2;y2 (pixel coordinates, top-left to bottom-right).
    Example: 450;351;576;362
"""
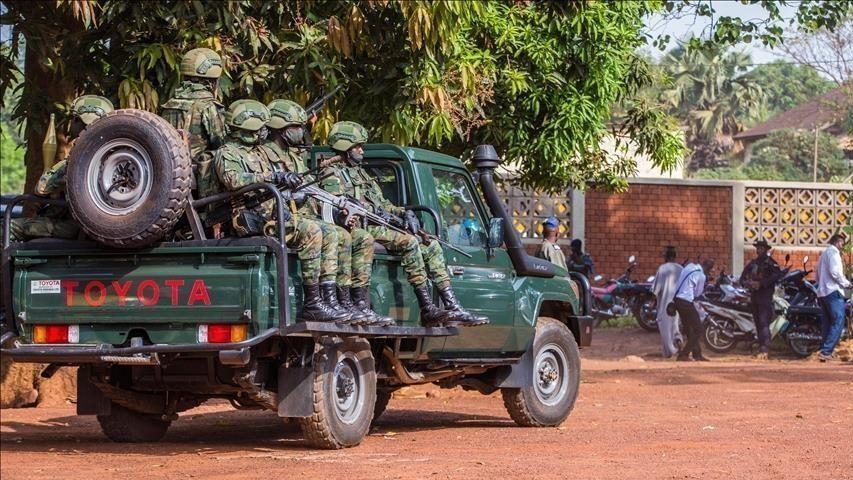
0;328;853;480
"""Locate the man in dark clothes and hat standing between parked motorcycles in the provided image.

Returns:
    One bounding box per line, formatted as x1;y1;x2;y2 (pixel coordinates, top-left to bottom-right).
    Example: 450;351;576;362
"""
741;239;785;360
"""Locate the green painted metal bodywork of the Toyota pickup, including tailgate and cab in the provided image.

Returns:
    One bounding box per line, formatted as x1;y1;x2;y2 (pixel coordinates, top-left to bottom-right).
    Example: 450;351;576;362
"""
12;144;578;358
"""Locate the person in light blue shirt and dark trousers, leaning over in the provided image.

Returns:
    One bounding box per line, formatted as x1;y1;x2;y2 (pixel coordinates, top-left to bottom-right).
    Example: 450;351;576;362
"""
675;258;714;362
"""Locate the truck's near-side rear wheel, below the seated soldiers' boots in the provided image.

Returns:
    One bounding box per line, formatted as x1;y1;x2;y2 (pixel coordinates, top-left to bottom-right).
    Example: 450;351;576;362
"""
298;338;376;449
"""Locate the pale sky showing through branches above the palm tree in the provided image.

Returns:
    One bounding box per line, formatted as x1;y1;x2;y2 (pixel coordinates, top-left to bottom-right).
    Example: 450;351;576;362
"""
646;0;797;64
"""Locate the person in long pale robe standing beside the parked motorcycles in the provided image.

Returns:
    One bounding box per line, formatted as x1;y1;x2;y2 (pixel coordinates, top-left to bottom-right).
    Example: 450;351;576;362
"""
652;245;684;358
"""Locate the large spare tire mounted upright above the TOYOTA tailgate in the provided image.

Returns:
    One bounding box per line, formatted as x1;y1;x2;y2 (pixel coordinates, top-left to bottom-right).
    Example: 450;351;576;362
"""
66;109;192;248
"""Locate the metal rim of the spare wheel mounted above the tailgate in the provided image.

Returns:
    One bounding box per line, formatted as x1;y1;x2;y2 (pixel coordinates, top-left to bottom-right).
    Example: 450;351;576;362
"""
86;138;153;215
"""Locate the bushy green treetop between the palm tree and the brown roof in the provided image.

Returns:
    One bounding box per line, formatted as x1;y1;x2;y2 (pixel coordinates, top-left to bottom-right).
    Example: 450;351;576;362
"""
747;60;833;121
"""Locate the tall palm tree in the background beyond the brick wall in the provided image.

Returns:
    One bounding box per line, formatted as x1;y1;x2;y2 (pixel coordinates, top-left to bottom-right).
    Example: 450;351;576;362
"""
661;43;764;170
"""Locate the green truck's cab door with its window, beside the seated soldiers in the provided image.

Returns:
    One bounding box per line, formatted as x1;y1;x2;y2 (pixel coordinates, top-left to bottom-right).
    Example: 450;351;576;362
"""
422;164;527;357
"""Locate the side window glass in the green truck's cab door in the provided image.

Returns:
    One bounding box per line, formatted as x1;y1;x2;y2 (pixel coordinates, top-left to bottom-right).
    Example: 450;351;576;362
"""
432;169;486;247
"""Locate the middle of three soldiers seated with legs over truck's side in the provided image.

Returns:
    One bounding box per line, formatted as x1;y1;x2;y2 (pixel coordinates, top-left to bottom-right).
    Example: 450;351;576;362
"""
257;100;386;326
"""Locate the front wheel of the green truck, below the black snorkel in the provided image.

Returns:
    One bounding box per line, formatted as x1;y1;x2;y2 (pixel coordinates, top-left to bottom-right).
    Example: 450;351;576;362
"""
501;318;580;427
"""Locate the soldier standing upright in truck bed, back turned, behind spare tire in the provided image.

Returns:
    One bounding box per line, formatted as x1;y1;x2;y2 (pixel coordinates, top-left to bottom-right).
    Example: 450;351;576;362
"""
161;48;228;198
